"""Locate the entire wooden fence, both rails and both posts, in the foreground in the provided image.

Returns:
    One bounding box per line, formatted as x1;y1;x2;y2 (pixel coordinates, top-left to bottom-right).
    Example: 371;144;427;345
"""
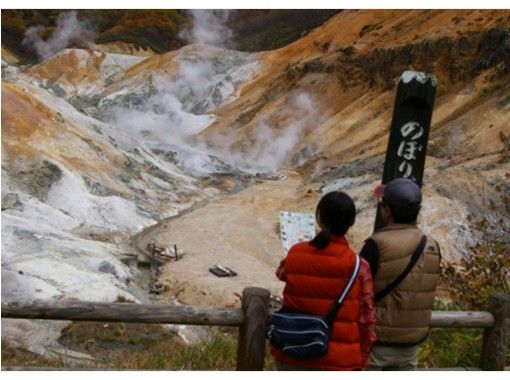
2;287;510;371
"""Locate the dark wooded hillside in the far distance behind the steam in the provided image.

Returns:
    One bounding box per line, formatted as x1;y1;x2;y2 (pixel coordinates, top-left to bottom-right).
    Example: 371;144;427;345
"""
2;9;338;61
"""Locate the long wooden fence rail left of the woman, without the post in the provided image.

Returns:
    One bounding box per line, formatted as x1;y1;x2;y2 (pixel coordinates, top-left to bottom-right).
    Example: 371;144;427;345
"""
2;302;244;326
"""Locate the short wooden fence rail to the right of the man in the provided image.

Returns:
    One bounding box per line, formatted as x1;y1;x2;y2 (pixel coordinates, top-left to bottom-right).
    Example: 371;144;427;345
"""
430;311;494;328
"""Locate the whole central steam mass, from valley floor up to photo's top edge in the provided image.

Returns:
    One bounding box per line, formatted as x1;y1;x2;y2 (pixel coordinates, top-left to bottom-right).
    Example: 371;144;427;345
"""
105;10;320;175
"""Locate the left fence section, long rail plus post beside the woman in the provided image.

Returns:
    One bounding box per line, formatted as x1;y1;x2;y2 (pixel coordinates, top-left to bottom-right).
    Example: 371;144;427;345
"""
2;287;270;371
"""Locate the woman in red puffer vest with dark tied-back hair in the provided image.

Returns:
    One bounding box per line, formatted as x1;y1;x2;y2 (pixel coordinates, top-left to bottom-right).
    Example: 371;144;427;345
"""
271;191;376;370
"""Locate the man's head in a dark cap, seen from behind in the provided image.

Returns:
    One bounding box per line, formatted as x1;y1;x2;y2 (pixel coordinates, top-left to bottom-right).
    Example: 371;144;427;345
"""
381;178;422;224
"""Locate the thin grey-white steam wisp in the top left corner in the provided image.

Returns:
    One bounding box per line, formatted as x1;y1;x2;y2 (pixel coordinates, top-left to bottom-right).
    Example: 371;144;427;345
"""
22;11;93;60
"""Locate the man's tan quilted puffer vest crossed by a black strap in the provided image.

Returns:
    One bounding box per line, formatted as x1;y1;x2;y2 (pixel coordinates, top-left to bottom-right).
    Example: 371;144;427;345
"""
371;224;441;345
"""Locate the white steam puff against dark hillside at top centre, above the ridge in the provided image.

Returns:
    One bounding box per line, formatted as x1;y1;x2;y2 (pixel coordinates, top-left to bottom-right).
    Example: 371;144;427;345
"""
180;9;232;47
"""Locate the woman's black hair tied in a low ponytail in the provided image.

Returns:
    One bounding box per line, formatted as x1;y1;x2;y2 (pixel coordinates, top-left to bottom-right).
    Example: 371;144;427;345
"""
310;191;356;249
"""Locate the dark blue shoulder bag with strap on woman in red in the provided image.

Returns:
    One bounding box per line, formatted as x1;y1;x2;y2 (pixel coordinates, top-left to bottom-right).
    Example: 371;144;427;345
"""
268;255;361;359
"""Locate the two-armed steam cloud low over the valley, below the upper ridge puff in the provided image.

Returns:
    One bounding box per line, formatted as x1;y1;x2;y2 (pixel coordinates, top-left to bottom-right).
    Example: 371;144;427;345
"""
111;61;319;175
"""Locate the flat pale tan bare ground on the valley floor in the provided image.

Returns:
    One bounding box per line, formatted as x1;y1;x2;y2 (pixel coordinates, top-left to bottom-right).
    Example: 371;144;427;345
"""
139;171;320;307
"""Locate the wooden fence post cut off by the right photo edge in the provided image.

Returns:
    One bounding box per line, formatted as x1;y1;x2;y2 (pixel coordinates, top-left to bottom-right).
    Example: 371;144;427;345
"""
480;293;510;371
